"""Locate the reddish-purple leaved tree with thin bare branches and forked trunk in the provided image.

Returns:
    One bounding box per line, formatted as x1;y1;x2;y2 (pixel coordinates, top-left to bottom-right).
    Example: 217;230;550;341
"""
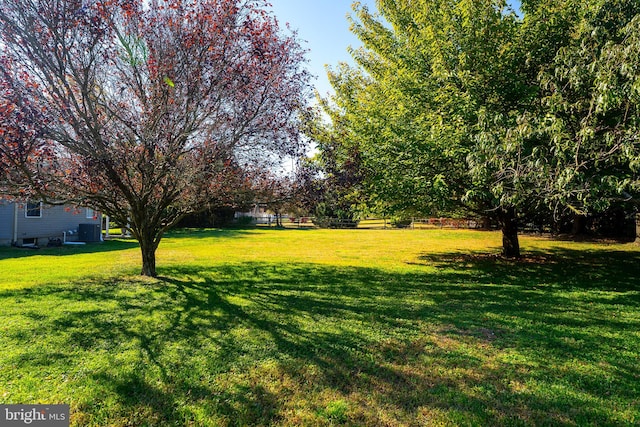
0;0;308;276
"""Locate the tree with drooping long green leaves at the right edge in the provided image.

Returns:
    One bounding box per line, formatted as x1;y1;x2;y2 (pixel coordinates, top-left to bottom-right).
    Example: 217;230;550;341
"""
532;0;640;234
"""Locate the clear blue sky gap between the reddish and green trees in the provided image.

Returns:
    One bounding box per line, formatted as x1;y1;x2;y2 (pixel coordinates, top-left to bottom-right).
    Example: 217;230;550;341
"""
271;0;520;95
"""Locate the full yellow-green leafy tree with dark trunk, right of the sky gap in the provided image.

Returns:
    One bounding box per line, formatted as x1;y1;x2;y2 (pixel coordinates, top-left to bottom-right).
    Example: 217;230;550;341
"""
325;0;536;256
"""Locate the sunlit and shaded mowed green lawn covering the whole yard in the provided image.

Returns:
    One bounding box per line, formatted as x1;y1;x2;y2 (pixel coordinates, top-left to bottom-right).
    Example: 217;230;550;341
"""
0;229;640;426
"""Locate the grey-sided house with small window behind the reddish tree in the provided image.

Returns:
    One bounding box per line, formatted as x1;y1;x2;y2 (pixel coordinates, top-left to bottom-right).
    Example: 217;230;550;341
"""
0;199;102;247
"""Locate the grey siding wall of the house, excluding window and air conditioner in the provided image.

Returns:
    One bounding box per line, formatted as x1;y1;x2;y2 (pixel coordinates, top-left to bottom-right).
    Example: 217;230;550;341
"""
0;204;102;246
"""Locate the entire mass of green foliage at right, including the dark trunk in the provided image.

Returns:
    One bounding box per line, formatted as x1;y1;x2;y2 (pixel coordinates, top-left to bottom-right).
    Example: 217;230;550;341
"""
318;0;640;256
